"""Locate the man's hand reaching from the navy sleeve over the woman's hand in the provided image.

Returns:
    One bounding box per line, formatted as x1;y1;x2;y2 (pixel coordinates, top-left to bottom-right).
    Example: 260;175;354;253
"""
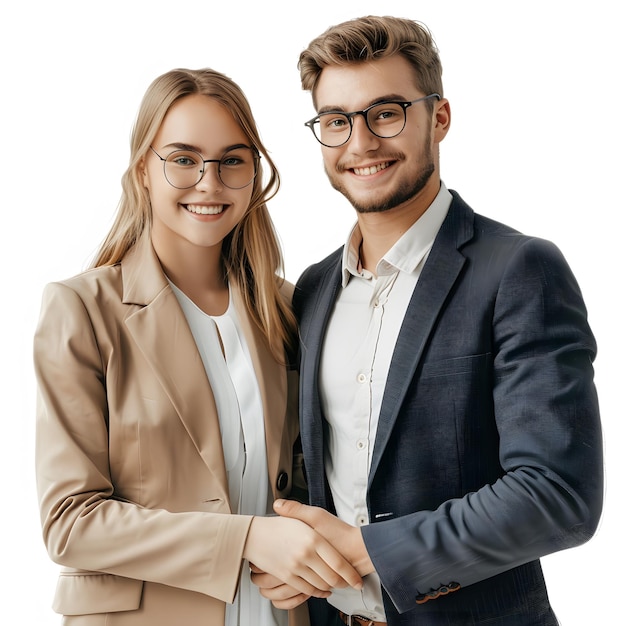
274;500;375;576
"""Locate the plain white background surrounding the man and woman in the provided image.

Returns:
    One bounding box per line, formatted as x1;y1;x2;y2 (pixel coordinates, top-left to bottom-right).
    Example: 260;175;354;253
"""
0;0;626;626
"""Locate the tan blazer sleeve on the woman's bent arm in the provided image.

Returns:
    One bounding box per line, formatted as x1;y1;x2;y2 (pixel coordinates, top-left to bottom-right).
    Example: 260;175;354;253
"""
34;283;252;602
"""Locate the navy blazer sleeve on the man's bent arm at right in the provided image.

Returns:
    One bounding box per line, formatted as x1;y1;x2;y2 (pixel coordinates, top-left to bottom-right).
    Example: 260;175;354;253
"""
362;239;603;612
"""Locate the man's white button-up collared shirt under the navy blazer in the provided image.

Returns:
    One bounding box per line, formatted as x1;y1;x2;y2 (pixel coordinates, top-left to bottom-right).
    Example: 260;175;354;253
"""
320;183;452;621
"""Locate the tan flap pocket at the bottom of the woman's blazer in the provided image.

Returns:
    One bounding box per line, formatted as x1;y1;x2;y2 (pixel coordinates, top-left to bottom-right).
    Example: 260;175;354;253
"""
52;570;143;615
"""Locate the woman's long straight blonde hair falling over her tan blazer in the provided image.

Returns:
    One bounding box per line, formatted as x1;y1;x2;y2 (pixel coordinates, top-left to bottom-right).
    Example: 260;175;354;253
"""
92;68;296;362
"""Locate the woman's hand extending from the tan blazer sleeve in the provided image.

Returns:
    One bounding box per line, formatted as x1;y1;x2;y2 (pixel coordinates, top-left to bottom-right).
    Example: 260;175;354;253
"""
243;517;363;601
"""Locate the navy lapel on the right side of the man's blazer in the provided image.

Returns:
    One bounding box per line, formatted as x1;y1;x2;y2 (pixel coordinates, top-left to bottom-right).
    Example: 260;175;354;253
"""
369;195;473;484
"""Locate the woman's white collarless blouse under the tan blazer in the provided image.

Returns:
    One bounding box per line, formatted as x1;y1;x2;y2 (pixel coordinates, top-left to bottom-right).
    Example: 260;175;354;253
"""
170;281;288;626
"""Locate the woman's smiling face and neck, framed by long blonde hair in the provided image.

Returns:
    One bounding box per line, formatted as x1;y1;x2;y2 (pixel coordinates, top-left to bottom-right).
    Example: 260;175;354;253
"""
140;94;257;280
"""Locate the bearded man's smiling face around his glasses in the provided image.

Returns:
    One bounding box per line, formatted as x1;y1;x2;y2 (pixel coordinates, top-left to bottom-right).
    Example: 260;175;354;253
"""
315;55;447;213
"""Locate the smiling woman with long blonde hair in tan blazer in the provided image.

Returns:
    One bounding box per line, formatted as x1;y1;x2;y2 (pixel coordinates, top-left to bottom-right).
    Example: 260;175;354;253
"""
34;69;358;626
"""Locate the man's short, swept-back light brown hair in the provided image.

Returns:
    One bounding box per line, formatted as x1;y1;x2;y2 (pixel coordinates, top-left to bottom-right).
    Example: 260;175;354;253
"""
298;15;443;107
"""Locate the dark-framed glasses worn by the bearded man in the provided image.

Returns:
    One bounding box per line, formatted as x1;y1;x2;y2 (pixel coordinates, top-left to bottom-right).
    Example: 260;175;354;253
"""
304;93;441;148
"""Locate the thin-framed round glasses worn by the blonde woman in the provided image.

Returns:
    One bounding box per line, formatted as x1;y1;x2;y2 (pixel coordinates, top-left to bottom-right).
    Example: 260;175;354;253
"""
150;145;261;189
